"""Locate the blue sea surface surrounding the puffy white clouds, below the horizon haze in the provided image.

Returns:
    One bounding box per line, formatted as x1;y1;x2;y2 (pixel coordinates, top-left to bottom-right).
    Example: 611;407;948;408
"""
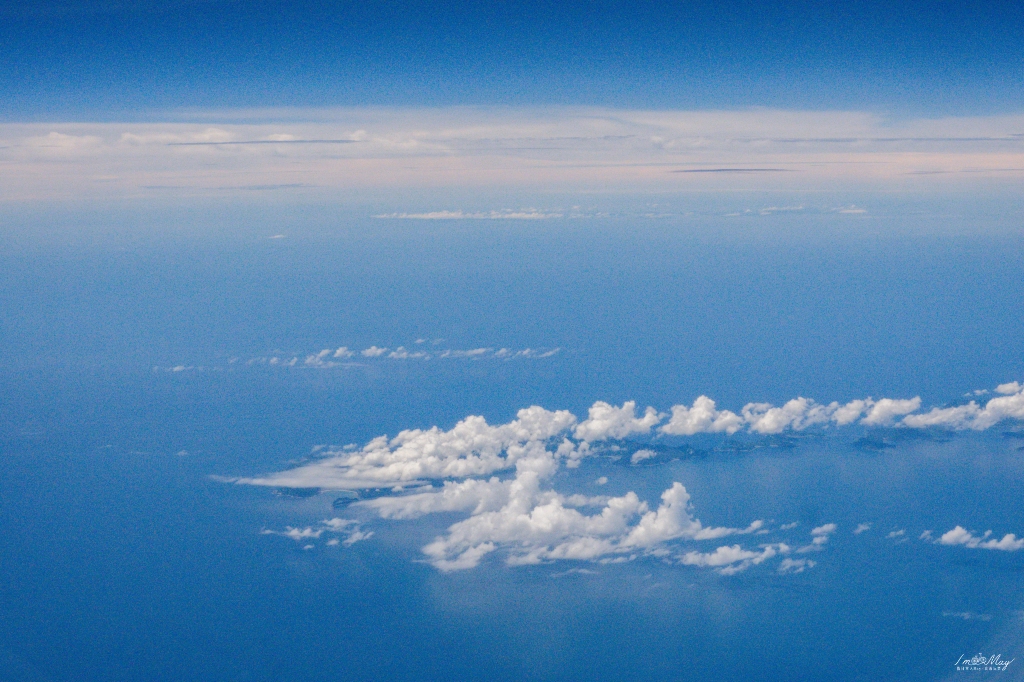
0;194;1024;681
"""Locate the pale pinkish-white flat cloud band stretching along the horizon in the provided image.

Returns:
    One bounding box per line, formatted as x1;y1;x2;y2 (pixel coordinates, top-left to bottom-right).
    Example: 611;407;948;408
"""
0;108;1024;199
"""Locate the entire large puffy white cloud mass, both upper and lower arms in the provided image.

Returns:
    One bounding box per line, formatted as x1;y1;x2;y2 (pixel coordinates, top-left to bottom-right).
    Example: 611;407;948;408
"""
241;382;1024;574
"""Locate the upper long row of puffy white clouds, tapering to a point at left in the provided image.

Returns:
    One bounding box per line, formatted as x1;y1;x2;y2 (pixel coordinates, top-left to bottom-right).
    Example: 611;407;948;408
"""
241;378;974;488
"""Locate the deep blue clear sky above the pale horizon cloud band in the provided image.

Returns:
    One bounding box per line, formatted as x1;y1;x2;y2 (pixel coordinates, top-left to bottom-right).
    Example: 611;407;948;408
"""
6;0;1024;120
